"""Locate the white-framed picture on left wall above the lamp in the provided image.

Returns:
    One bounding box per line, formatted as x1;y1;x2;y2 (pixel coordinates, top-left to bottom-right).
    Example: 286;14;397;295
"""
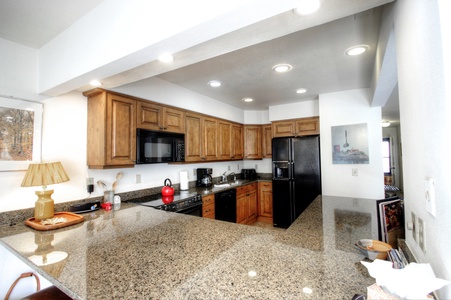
0;96;43;172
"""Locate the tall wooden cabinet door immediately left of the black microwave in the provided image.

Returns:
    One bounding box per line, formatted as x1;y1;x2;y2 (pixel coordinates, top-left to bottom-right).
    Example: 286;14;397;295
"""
106;94;136;166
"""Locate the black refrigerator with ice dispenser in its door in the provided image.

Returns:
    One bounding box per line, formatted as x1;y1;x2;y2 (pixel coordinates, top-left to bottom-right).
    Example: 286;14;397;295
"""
272;135;321;228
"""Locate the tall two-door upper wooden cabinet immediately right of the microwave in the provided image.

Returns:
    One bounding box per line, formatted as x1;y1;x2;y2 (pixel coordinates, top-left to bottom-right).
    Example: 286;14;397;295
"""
185;112;218;162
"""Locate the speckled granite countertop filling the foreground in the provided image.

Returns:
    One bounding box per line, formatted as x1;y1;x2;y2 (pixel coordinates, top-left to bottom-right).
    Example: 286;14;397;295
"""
0;196;377;299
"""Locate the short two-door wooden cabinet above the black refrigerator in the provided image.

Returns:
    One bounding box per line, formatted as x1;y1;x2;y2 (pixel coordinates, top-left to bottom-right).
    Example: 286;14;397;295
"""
272;117;319;137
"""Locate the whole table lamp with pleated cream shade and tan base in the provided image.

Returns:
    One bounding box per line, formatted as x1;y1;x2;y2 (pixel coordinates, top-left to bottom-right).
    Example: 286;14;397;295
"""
21;162;69;220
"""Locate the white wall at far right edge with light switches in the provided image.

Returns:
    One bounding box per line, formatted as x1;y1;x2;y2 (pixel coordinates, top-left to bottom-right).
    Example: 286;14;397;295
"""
395;0;451;299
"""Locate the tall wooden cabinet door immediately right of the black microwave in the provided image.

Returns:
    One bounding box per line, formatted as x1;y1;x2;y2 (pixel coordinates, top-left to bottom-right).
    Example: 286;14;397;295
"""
185;113;203;161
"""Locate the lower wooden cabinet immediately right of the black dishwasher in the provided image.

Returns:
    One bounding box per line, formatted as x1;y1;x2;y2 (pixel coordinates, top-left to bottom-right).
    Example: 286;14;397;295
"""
236;182;258;225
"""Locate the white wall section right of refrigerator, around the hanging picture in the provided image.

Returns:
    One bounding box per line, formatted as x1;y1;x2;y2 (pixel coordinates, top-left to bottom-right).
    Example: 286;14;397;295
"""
319;89;384;199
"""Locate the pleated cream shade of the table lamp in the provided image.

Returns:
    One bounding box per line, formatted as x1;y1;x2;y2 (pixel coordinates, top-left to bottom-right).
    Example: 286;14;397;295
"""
21;161;69;187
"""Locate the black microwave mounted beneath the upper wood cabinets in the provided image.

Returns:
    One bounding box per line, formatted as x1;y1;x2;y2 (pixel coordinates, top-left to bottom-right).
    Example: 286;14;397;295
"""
136;128;185;164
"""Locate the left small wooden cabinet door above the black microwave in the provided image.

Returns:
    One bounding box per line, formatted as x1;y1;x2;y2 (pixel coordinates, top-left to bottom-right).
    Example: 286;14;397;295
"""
136;101;163;130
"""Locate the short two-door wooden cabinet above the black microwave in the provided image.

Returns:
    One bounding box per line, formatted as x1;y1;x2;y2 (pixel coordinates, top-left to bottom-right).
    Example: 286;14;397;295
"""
136;101;185;133
